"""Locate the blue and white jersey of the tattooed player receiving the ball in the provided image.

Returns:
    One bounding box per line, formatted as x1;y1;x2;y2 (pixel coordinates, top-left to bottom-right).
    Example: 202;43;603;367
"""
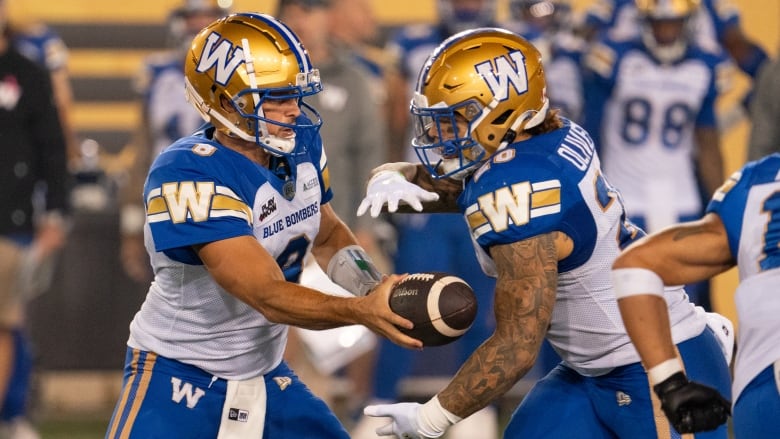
458;120;706;376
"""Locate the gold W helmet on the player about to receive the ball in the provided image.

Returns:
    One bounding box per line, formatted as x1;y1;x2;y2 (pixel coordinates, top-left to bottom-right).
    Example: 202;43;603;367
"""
411;28;549;178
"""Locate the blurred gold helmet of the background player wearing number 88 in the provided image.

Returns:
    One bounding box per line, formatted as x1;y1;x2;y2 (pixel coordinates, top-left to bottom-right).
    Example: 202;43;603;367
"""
635;0;700;63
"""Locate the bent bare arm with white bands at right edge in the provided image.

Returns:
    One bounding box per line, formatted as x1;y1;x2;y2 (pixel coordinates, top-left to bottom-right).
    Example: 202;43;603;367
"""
612;213;736;370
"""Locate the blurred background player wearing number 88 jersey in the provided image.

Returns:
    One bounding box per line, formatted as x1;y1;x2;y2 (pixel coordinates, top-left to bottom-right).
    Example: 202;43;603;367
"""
585;0;732;310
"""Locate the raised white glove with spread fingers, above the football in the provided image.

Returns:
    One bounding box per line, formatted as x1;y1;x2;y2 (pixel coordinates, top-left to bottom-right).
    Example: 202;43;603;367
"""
357;170;439;218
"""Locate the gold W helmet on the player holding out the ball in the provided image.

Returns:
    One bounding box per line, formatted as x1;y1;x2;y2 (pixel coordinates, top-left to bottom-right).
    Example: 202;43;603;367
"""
184;13;322;156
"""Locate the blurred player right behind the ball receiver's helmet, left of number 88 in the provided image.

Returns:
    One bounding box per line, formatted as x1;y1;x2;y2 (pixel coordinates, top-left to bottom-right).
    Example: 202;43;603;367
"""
504;0;585;121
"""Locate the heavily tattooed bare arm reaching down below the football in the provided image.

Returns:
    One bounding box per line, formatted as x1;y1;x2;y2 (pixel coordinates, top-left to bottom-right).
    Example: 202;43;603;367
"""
438;233;570;417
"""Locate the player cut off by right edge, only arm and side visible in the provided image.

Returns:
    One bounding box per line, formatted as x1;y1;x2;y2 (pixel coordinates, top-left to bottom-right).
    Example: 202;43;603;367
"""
612;154;780;439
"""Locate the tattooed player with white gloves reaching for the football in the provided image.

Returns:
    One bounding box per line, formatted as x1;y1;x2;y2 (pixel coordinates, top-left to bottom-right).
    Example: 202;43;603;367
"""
358;28;730;439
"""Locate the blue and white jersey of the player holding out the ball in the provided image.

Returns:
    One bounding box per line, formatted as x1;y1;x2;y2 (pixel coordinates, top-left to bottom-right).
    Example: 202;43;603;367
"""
128;124;332;380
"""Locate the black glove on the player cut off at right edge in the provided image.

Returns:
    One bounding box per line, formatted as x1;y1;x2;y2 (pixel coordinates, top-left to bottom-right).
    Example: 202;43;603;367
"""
653;372;731;434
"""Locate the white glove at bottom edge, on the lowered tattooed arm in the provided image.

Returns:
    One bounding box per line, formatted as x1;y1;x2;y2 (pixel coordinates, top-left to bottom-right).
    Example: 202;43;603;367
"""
363;396;461;439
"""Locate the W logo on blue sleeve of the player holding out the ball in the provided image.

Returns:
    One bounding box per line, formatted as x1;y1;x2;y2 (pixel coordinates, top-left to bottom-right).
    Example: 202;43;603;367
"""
162;181;214;223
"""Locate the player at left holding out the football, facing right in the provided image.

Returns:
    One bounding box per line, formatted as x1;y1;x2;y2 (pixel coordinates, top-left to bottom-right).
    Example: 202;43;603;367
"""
106;13;422;439
